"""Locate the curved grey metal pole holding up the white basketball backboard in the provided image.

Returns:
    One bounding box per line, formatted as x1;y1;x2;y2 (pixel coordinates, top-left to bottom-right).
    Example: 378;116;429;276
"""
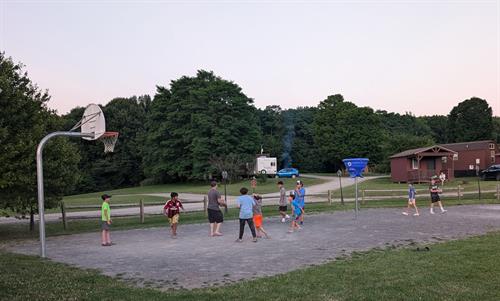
36;132;94;257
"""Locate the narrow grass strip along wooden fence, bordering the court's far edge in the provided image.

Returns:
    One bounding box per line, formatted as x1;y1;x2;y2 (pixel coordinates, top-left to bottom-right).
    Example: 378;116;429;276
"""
0;199;498;242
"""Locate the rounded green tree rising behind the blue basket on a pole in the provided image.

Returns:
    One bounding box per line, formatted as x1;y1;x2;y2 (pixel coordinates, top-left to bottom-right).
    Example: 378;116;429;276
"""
314;94;382;171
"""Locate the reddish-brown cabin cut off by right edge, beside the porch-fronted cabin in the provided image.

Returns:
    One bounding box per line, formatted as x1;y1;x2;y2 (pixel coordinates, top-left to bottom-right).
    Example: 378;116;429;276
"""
440;140;500;177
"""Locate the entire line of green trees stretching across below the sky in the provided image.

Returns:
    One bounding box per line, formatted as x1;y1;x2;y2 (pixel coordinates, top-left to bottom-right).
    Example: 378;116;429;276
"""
0;53;500;219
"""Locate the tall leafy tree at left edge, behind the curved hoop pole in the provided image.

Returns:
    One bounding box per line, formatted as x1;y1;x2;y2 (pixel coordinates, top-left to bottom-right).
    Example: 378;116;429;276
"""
0;53;79;228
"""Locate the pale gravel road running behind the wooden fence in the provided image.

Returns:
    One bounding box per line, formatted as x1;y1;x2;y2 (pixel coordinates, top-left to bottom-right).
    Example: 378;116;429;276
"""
0;174;375;224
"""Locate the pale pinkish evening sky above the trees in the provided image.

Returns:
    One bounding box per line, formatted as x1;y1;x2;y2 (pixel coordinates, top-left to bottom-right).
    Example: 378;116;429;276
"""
0;0;500;116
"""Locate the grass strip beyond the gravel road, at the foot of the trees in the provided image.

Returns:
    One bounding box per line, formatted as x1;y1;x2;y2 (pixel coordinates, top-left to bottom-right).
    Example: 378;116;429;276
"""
59;178;325;211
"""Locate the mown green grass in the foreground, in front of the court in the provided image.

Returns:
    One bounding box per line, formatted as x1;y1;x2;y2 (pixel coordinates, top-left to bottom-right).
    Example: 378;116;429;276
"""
0;233;500;301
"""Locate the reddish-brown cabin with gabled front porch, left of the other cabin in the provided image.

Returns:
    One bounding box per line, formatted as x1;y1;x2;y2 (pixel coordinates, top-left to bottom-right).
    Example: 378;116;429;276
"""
390;145;457;183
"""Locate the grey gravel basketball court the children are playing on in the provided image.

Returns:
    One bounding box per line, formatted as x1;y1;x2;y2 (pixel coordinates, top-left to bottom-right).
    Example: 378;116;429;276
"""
8;205;500;289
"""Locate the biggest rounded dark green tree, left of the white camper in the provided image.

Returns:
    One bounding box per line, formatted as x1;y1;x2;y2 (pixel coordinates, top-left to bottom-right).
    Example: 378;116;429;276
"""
143;70;261;182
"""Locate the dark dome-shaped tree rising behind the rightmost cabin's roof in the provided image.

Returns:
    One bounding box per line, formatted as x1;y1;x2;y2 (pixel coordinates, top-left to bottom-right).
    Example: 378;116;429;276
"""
447;97;494;142
